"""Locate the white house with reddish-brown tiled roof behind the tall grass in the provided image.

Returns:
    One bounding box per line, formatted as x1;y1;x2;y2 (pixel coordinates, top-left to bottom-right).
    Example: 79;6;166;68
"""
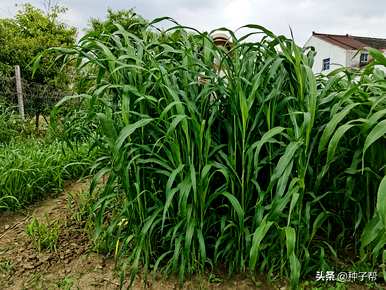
305;32;386;73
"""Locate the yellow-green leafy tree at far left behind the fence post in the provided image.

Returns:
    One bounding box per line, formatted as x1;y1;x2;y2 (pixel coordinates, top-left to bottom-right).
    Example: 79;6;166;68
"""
0;4;77;123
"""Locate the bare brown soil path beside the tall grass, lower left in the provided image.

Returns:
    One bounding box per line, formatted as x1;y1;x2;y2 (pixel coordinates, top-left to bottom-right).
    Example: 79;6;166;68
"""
0;181;122;289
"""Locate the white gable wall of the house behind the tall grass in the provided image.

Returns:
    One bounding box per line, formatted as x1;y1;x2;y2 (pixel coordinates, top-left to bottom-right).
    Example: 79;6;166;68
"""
305;35;346;73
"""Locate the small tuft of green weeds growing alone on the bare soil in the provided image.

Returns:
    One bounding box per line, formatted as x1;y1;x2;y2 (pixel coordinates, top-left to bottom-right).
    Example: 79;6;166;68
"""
26;217;60;252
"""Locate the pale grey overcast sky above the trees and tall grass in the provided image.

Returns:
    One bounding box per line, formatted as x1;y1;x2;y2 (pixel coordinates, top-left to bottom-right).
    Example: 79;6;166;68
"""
0;0;386;45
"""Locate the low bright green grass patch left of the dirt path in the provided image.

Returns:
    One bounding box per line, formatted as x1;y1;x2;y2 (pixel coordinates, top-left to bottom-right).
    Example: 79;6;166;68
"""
0;138;91;210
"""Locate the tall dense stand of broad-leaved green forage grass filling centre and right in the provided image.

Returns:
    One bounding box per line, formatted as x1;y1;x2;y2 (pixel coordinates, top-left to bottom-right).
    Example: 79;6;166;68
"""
47;20;386;287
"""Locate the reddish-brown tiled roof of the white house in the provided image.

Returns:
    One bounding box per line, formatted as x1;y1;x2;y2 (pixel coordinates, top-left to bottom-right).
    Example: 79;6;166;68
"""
312;32;386;50
